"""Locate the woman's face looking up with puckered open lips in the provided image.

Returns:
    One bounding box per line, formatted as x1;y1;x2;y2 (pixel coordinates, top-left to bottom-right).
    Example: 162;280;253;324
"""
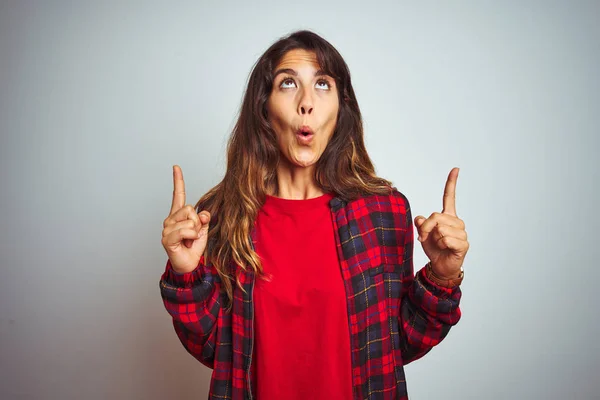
267;49;339;167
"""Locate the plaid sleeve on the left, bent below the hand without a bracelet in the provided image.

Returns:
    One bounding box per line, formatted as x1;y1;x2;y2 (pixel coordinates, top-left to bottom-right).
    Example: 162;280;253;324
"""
160;257;221;368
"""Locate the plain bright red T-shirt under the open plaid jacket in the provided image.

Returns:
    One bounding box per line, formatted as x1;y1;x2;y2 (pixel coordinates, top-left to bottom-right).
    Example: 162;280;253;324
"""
252;194;352;400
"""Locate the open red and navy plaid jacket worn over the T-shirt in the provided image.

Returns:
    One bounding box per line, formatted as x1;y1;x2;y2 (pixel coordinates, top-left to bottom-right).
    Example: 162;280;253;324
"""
160;188;461;400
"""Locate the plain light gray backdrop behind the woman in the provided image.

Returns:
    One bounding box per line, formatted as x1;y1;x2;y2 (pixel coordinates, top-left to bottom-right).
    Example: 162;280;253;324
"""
0;0;600;400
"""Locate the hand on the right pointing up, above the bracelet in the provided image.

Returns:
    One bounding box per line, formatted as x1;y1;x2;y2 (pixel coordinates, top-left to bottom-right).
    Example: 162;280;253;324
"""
415;168;469;279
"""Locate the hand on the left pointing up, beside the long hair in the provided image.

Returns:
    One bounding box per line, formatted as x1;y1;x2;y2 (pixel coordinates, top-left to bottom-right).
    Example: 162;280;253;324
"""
162;165;210;273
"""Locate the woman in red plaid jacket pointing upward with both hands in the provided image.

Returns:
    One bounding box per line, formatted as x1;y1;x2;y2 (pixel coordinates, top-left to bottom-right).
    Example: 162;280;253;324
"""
160;31;468;400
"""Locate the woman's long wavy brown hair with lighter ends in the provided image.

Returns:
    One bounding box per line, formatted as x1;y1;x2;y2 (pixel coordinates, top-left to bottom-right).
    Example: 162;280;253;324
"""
196;30;391;311
